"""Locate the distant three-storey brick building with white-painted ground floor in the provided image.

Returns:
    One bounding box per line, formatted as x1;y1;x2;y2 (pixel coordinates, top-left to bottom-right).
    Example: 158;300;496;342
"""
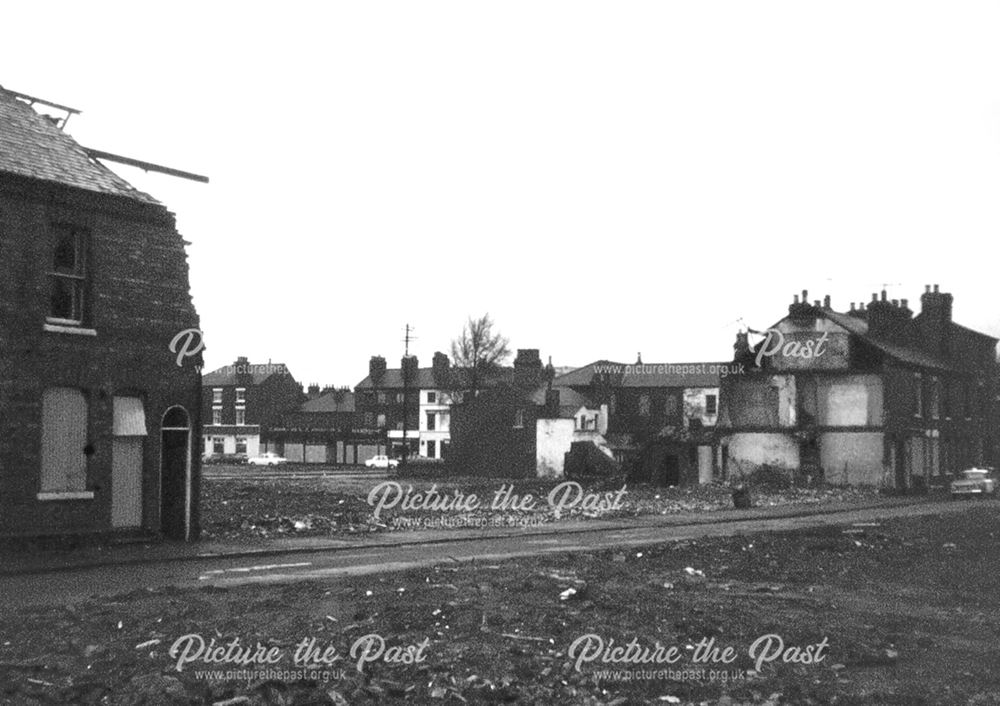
202;356;304;459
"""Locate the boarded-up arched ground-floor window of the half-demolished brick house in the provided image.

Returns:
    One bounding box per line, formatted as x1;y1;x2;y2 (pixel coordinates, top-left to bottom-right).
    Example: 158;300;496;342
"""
41;387;87;493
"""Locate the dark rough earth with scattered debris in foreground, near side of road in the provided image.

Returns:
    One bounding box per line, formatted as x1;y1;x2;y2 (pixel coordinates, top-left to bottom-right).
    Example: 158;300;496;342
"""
0;502;1000;706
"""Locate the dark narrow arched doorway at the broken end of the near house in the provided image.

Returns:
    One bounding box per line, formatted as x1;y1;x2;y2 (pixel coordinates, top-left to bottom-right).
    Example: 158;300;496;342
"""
160;407;191;540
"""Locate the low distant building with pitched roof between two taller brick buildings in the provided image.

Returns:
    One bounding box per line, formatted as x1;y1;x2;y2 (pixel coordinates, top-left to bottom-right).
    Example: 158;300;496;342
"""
262;385;385;465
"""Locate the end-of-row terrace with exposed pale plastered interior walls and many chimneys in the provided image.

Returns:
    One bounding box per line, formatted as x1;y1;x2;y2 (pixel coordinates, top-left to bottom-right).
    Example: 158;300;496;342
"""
719;285;998;491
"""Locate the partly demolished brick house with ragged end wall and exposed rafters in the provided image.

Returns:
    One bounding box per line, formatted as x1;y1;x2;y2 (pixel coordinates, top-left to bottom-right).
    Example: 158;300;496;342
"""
0;88;201;539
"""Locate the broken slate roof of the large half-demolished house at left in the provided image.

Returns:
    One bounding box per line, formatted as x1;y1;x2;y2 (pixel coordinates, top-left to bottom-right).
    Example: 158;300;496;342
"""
0;86;162;206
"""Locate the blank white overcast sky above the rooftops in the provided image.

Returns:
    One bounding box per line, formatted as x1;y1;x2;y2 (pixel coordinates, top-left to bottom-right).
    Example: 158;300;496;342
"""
0;0;1000;386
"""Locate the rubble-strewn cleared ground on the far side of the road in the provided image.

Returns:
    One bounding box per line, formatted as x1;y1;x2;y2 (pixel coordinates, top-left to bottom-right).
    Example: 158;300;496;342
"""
201;466;877;539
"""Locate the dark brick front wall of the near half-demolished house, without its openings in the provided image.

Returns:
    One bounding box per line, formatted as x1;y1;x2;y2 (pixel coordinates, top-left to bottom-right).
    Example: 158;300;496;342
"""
0;175;201;536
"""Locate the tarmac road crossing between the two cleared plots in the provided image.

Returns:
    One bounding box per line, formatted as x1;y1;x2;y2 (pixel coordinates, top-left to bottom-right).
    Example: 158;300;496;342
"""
0;500;984;613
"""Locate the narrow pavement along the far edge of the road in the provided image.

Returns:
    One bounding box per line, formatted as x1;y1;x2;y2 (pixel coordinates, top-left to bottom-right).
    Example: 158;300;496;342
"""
0;496;940;576
